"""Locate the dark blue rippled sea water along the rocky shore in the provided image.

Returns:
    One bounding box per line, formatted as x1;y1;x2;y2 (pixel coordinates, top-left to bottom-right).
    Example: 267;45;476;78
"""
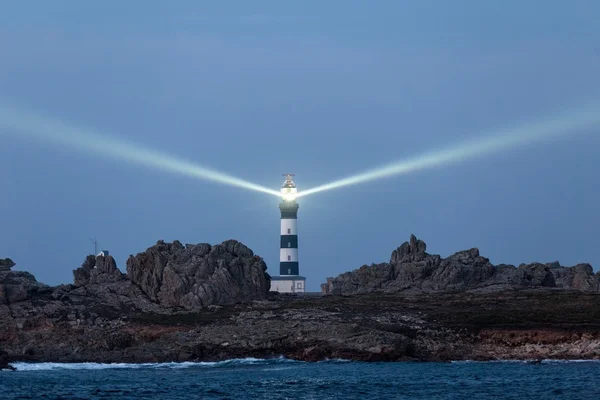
0;359;600;400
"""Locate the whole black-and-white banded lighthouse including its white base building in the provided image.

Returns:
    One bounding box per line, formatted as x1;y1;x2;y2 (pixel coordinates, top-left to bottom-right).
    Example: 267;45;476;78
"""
271;174;306;293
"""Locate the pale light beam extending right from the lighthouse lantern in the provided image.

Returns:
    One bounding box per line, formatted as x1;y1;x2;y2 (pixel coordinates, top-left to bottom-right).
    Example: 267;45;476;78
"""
298;104;600;197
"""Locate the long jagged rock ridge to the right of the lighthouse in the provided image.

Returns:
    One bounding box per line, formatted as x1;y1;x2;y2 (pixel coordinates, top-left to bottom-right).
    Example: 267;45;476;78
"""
321;235;600;295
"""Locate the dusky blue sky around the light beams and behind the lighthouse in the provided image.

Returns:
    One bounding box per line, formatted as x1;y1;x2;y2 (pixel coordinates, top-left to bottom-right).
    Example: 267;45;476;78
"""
0;0;600;290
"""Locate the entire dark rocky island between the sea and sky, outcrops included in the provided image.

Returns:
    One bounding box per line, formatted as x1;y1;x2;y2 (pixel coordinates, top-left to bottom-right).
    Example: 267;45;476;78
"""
0;236;600;369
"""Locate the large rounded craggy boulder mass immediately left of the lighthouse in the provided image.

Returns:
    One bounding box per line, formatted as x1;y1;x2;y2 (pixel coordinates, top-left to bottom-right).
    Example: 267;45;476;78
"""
127;240;271;310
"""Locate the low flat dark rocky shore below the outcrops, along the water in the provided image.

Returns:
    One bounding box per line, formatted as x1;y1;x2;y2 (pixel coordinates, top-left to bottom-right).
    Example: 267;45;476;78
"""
4;290;600;363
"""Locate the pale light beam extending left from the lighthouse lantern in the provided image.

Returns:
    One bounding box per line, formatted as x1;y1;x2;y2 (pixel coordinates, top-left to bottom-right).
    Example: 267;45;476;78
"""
0;106;280;197
